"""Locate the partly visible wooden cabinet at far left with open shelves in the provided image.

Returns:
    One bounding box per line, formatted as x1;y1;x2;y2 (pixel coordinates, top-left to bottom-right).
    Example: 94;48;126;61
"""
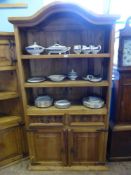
0;32;26;167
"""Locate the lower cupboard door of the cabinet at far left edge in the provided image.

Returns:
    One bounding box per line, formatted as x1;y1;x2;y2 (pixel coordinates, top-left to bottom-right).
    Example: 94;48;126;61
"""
0;126;22;165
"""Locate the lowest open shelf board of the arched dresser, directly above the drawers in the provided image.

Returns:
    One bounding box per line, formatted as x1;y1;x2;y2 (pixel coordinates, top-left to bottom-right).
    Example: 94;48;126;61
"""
26;105;107;116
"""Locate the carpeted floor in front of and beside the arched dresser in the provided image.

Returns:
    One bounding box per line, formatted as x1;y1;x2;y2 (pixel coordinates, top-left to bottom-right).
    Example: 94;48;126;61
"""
0;160;131;175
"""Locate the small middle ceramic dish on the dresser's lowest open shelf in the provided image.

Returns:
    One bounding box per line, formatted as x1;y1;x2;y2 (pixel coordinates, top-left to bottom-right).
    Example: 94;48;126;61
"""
54;100;71;109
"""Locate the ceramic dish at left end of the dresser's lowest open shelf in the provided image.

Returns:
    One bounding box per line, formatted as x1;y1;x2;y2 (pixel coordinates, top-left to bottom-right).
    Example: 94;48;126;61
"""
35;95;53;108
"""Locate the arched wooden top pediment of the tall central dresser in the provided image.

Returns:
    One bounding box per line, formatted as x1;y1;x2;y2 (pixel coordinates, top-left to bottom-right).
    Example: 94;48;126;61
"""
9;2;119;27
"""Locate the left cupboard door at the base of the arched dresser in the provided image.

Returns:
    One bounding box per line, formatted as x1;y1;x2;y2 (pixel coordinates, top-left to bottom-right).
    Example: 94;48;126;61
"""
29;128;66;165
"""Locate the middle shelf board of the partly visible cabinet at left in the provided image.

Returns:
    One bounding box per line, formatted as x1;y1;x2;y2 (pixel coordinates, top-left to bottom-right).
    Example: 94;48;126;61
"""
0;91;18;100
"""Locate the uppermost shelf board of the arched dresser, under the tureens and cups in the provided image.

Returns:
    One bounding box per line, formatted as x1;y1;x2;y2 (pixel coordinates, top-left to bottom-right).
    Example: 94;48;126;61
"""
21;53;110;60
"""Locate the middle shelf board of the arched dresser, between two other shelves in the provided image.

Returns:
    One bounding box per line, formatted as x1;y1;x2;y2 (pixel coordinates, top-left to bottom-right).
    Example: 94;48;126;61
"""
24;80;109;88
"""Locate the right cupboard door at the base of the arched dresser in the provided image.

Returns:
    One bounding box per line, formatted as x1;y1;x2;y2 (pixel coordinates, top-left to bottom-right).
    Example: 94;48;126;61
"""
68;128;105;165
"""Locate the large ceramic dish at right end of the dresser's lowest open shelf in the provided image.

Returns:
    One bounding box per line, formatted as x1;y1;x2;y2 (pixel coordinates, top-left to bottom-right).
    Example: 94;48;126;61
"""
82;96;104;109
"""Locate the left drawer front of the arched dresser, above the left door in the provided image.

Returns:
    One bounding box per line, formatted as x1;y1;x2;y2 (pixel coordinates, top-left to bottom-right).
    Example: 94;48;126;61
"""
29;115;65;126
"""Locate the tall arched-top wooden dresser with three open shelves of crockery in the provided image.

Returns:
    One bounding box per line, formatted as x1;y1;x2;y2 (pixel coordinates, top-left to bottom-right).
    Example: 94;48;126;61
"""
9;2;117;170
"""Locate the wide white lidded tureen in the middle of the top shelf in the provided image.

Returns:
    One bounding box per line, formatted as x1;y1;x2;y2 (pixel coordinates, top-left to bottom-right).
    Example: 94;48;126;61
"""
46;44;71;54
